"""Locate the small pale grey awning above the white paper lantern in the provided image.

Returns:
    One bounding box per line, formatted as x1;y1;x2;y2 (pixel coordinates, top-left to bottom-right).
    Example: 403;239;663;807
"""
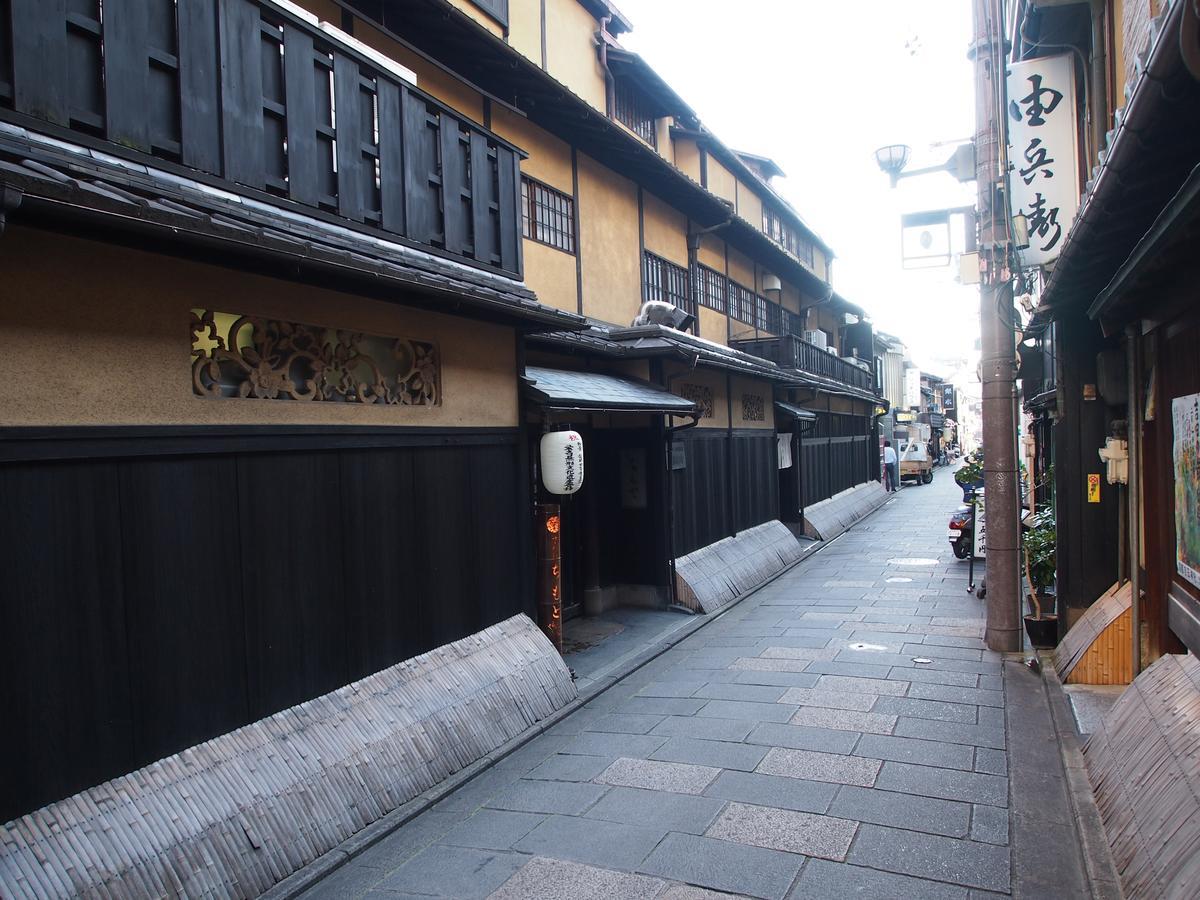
526;366;696;415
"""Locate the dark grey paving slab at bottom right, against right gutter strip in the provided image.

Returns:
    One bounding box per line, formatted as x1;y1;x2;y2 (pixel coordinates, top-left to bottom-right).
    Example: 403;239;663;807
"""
847;824;1009;893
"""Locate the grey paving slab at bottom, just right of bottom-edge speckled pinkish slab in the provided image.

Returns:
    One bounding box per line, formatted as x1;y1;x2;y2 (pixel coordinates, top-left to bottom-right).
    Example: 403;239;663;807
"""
641;834;804;900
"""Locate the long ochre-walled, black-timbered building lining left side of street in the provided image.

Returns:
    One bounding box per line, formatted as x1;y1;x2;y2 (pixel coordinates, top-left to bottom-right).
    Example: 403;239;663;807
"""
0;0;878;888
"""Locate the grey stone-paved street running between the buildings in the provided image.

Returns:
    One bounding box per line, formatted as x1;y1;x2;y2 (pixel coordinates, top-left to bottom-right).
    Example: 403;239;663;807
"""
297;469;1087;900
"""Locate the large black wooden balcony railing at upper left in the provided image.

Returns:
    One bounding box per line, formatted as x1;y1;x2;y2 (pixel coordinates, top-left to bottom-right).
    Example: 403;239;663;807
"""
0;0;522;277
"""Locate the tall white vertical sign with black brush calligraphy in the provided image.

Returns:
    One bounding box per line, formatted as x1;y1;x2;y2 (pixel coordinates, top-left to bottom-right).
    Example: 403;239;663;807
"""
1008;54;1079;265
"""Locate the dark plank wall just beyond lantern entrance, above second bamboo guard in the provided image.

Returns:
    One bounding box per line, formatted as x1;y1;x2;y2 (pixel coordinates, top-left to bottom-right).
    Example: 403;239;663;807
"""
672;428;779;557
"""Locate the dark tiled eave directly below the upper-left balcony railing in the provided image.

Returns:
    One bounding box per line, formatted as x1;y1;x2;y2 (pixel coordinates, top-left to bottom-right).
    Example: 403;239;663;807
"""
0;122;586;330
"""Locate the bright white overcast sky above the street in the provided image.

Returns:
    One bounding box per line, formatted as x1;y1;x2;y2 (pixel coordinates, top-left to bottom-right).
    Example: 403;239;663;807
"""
617;0;979;374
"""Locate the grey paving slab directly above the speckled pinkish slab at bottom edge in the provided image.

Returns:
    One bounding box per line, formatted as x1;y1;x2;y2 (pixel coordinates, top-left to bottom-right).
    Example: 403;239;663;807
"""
512;816;666;870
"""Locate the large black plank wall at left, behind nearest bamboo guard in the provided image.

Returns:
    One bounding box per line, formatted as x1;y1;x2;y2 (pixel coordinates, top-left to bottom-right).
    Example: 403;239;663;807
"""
0;430;533;821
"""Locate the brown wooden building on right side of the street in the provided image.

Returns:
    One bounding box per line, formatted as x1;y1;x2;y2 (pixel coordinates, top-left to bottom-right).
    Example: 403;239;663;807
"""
1013;0;1200;898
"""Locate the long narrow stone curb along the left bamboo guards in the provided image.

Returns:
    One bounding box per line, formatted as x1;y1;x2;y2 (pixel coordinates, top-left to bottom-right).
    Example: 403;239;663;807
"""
267;505;883;900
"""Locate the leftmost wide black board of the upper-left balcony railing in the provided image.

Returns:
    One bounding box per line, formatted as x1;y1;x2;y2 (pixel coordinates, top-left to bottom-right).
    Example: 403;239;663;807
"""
11;0;71;125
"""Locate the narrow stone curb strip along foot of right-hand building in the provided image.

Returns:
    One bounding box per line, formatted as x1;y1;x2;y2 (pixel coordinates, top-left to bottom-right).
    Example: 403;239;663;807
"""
1039;652;1124;900
